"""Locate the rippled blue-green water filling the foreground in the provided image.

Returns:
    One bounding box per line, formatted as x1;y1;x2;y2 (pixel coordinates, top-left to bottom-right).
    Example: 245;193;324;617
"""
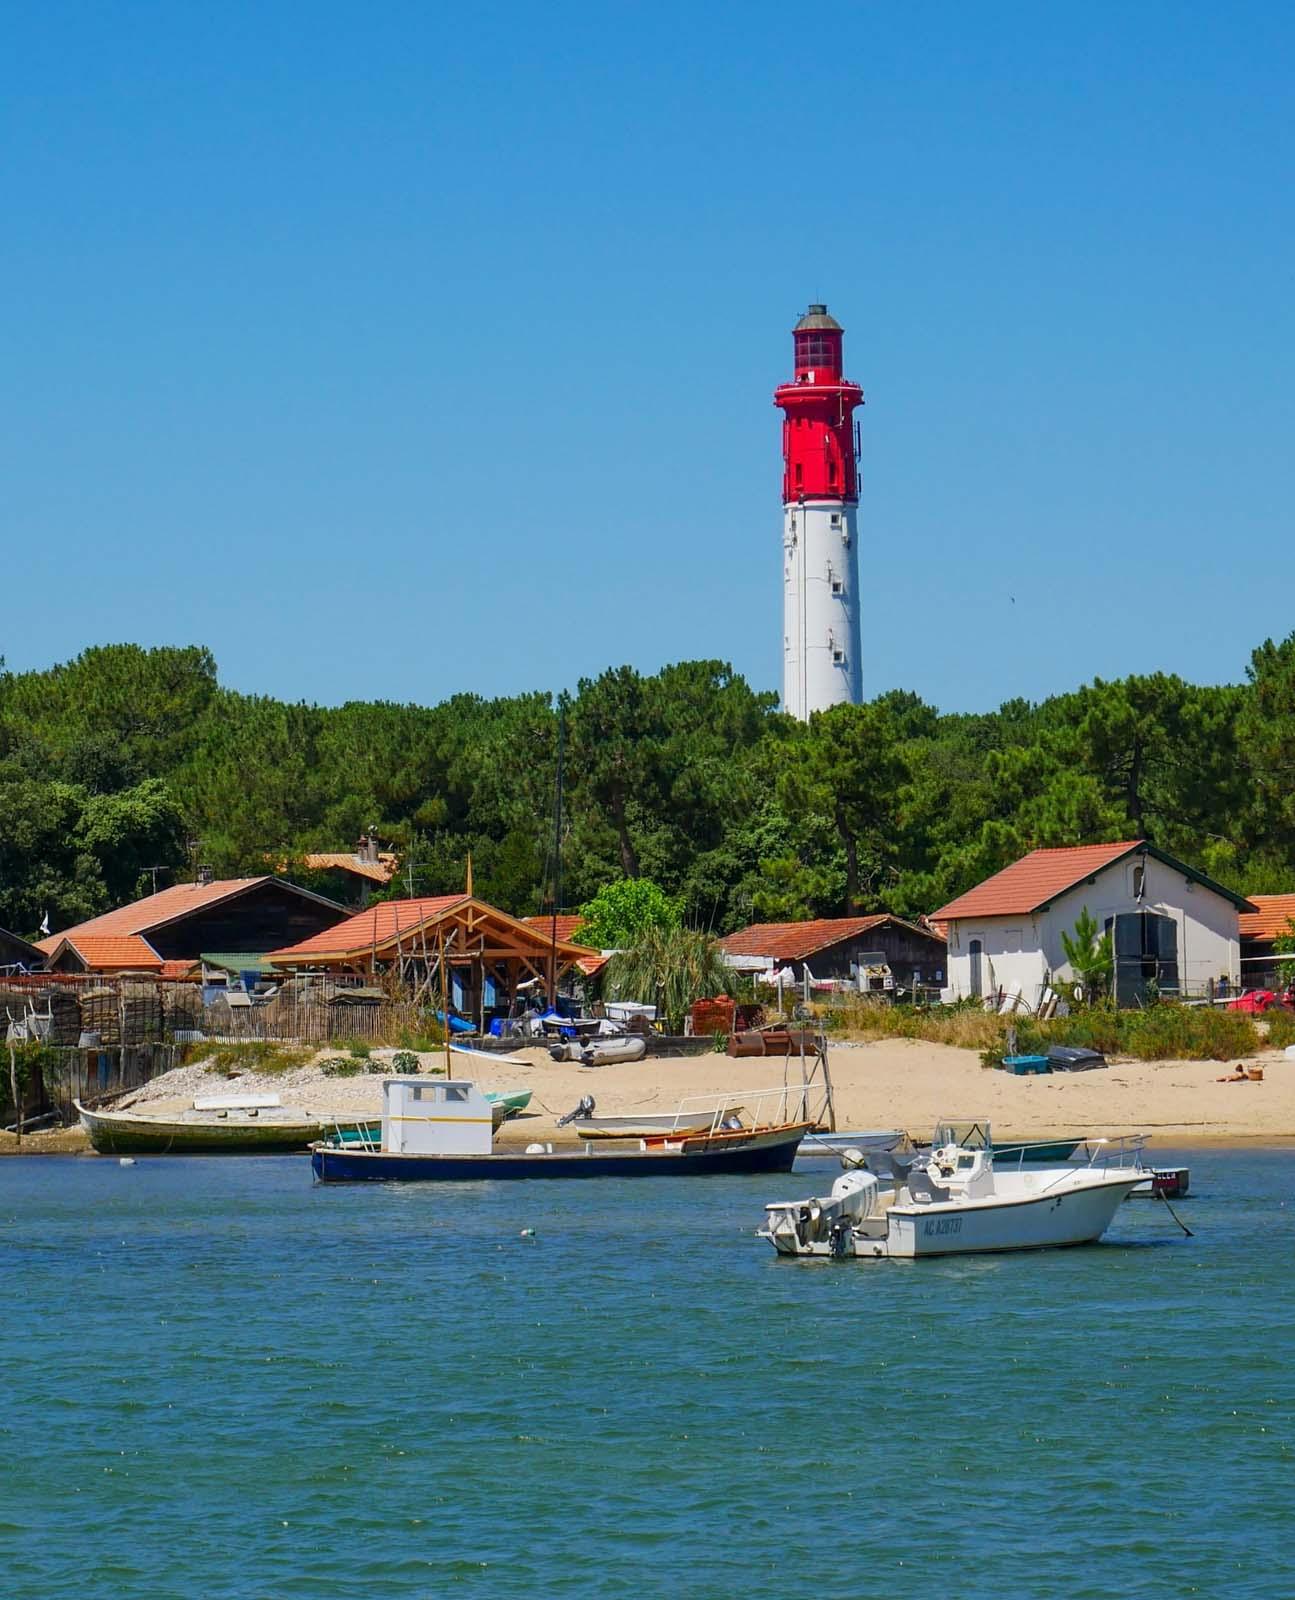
0;1152;1295;1600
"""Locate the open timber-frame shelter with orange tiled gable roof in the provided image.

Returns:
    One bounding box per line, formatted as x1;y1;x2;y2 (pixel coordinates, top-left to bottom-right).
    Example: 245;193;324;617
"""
269;894;600;1019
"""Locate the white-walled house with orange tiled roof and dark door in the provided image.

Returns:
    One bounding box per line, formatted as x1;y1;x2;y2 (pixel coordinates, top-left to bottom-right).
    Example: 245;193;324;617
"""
932;838;1255;1010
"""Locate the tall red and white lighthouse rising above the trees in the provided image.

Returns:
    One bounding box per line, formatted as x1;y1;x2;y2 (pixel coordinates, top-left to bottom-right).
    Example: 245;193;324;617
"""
773;306;863;722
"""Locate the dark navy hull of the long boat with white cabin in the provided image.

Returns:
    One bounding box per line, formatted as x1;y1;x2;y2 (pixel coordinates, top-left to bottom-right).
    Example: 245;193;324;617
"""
311;1123;808;1184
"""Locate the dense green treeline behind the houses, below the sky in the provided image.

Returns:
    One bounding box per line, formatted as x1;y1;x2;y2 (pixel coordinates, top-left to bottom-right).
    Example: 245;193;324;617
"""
0;635;1295;936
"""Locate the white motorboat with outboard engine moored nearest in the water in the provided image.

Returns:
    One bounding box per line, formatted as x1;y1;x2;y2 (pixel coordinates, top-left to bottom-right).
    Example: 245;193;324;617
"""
760;1120;1148;1259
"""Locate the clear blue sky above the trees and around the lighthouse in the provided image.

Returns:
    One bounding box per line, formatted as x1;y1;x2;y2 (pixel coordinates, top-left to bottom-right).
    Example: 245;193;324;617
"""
0;0;1295;710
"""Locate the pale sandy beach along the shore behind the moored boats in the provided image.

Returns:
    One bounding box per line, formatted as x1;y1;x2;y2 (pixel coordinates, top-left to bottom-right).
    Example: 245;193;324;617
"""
3;1038;1295;1152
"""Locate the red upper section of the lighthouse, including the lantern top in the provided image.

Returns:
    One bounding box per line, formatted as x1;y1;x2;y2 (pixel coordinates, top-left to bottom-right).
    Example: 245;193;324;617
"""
773;306;863;504
